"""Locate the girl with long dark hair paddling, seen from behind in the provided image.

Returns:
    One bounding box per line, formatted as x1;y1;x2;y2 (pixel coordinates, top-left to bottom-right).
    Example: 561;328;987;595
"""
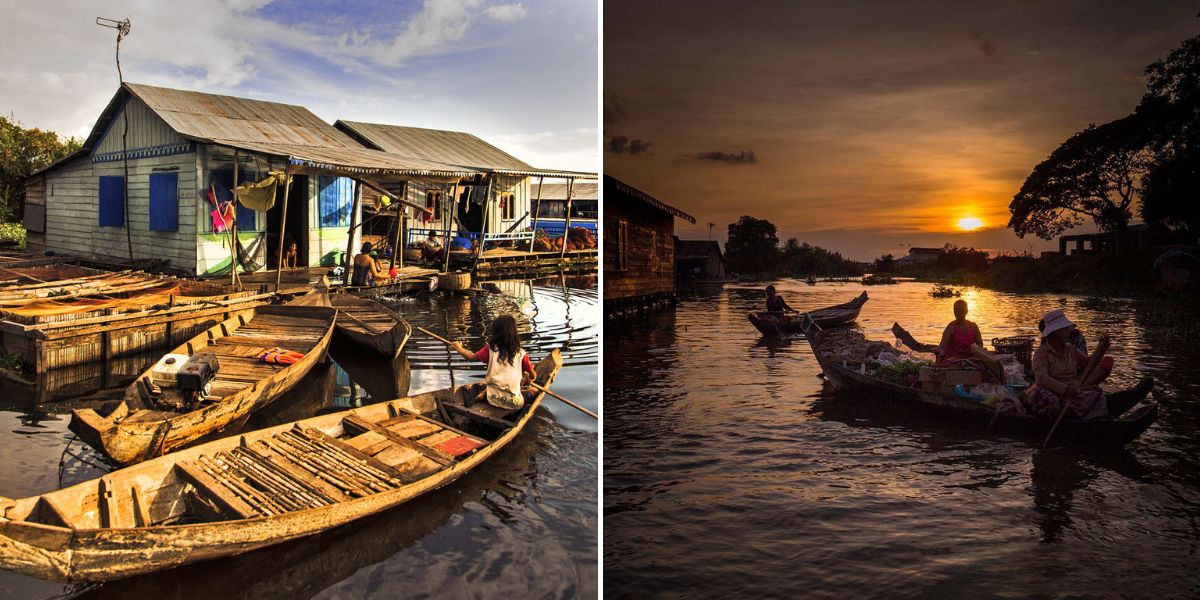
451;314;538;410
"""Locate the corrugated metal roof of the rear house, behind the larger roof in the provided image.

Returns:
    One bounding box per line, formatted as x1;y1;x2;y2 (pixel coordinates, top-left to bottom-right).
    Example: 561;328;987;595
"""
334;120;536;172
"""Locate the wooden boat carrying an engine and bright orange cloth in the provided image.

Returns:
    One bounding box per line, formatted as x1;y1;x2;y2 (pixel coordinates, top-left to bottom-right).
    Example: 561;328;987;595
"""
68;305;337;464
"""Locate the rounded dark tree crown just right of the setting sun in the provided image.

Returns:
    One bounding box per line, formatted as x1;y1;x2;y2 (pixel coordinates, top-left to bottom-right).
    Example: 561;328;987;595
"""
1008;115;1150;240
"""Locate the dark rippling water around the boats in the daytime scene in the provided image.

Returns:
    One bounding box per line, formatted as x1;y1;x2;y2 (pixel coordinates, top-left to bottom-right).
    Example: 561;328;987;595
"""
0;277;600;600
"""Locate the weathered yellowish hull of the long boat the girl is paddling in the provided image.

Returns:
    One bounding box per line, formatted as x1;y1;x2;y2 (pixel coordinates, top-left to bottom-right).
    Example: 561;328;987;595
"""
0;350;562;582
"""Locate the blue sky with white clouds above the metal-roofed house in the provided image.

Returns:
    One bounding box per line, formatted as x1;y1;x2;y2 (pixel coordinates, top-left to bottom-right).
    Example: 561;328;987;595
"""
0;0;599;170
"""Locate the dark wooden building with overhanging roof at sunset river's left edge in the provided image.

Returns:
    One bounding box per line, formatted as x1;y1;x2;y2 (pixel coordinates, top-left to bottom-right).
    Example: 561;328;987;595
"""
601;175;696;317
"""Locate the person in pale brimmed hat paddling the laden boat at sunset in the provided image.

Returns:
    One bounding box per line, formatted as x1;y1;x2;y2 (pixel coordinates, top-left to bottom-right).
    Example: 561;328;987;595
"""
1027;310;1112;419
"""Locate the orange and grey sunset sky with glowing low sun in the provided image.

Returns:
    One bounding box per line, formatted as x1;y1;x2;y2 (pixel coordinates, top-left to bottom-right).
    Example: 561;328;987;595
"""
604;0;1200;259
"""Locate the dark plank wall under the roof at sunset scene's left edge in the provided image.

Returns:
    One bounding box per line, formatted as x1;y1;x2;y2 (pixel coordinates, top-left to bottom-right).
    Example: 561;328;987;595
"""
601;190;676;302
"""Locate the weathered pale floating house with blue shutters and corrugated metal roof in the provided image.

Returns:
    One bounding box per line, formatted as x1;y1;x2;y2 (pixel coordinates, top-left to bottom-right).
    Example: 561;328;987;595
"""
25;83;595;276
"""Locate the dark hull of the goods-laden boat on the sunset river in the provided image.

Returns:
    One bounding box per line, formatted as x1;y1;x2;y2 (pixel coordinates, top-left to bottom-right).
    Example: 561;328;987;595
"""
804;319;1158;445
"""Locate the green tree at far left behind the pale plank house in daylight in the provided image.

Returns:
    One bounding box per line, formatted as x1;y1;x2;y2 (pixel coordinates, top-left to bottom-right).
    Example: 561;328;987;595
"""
0;116;83;221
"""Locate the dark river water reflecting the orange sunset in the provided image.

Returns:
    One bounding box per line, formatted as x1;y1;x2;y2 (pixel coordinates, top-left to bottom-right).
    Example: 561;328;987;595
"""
604;280;1200;598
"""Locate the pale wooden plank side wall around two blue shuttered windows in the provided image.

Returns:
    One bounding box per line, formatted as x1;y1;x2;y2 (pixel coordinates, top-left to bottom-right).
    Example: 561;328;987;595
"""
46;146;200;271
